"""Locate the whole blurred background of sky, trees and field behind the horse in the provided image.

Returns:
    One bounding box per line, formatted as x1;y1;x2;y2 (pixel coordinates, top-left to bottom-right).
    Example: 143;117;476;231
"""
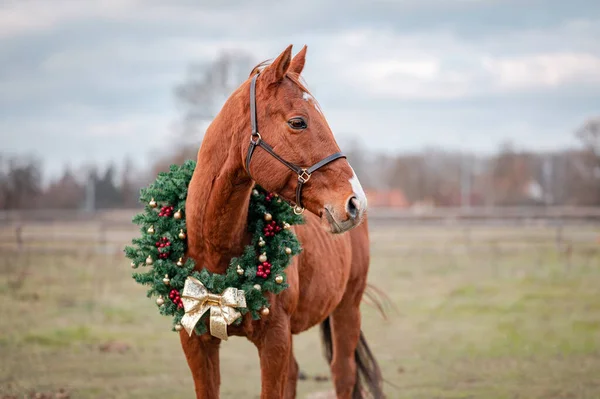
0;0;600;398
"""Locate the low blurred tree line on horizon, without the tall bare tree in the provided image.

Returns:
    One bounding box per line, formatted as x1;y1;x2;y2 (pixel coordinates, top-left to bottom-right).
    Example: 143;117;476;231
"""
0;129;600;209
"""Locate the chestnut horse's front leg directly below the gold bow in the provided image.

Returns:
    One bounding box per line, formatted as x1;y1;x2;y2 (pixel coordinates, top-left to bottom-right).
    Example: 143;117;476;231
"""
179;330;221;399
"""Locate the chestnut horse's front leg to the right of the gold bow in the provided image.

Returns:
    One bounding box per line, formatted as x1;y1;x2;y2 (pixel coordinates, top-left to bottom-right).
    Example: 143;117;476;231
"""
254;311;292;399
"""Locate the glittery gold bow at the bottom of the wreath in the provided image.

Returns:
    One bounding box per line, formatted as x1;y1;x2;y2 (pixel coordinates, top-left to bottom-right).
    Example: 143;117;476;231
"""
181;277;246;341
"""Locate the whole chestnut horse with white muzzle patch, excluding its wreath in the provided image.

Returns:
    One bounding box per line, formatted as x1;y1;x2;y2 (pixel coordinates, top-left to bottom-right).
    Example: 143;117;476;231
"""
180;46;383;399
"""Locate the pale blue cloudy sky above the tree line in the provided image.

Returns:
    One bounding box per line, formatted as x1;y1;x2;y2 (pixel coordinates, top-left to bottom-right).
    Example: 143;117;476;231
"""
0;0;600;181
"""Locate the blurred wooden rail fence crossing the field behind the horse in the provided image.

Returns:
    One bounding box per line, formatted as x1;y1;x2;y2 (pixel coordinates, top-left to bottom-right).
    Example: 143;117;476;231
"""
0;208;600;255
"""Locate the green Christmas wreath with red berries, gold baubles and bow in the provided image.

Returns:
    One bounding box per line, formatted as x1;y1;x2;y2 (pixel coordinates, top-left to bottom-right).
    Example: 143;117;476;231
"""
125;161;303;339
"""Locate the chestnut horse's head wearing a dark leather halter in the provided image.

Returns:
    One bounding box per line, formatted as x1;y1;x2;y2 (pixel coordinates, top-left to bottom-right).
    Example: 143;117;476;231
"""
242;46;367;233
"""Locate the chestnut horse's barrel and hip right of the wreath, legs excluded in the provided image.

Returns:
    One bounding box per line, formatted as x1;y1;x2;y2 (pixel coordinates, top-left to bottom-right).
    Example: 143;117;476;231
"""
288;214;369;334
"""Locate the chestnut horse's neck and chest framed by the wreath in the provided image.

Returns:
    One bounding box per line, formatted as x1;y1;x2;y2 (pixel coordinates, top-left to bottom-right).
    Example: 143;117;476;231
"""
186;116;253;274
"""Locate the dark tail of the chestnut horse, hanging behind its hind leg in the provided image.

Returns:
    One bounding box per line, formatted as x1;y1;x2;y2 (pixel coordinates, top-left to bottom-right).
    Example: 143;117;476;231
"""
321;317;385;399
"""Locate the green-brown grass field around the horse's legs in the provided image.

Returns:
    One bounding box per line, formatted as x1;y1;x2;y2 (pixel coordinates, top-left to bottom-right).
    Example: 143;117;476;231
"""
0;226;600;399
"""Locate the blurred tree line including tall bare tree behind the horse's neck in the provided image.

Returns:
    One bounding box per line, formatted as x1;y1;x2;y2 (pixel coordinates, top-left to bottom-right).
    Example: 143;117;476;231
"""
0;51;600;210
